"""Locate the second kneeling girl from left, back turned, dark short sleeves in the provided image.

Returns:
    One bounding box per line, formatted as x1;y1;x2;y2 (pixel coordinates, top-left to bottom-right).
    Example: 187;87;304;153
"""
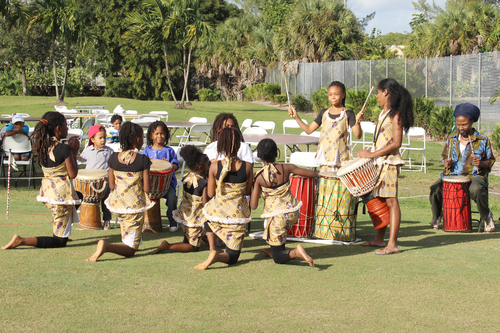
87;122;154;261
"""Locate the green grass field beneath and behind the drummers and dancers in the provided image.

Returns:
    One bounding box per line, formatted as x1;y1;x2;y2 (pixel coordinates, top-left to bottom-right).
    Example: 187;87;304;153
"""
0;97;500;332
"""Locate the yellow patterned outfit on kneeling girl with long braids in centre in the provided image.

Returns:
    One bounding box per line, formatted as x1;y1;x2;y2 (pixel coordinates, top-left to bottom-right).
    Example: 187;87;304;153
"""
203;156;252;251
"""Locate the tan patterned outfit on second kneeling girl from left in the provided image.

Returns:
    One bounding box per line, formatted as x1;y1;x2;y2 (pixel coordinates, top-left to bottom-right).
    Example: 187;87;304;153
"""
104;150;154;250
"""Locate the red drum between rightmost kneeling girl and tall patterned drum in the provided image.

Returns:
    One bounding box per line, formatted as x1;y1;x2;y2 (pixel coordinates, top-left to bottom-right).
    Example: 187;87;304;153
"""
287;175;315;238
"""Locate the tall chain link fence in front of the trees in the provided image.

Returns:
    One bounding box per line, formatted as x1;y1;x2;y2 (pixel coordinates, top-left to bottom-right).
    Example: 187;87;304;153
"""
266;52;500;132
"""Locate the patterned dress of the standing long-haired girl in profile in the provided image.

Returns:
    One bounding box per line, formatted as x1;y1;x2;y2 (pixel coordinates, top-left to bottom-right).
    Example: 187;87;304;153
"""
372;110;405;198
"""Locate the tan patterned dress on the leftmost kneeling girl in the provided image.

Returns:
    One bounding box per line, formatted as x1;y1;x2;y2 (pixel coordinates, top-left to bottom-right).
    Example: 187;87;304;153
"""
36;154;81;238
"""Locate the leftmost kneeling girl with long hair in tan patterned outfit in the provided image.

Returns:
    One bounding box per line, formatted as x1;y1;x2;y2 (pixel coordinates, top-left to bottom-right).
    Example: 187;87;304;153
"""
2;112;81;250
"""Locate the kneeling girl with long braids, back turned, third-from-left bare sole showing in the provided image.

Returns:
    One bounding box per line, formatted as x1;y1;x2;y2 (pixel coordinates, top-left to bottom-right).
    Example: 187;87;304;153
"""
194;127;253;270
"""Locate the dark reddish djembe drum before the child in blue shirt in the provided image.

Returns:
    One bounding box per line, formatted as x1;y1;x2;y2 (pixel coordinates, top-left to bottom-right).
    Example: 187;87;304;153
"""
142;159;174;233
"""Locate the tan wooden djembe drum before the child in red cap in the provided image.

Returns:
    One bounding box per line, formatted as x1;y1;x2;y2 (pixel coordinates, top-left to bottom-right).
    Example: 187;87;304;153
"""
73;169;108;230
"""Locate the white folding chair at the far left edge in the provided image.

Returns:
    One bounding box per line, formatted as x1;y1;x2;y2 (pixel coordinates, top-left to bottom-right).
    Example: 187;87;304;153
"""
0;134;36;189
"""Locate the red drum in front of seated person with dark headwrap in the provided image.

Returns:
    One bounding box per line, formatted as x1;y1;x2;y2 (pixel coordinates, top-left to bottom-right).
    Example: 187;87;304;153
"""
443;176;472;232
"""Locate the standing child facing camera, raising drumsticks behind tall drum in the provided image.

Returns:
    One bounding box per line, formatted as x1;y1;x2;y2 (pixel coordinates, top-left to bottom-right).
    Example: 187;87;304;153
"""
288;81;363;171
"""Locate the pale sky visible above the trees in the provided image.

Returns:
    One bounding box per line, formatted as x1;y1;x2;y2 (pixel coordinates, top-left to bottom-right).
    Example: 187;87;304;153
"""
347;0;446;35
